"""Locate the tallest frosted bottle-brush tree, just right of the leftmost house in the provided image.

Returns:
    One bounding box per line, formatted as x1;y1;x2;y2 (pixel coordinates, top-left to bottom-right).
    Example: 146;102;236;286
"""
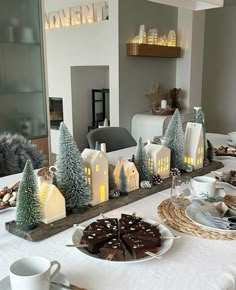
56;122;91;209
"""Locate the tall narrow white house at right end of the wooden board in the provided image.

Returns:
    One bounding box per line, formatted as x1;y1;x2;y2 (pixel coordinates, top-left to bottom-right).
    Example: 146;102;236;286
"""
184;122;204;169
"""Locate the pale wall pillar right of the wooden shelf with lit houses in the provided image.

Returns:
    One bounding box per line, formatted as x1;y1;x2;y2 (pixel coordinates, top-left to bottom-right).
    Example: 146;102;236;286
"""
176;8;205;109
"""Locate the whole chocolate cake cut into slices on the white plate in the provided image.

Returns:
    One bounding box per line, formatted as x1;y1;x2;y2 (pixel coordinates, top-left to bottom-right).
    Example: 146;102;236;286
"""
81;214;161;261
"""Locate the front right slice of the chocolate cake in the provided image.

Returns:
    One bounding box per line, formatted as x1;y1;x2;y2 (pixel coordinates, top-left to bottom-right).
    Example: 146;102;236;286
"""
122;235;159;259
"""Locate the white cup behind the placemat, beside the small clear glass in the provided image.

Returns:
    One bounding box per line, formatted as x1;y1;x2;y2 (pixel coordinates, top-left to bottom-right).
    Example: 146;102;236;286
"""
192;176;216;197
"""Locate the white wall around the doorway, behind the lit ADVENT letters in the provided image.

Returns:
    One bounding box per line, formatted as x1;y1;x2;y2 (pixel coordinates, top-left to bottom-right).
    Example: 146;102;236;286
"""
45;0;119;153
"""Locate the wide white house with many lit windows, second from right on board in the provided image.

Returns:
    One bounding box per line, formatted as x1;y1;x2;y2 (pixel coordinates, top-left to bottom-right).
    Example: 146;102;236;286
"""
144;142;171;178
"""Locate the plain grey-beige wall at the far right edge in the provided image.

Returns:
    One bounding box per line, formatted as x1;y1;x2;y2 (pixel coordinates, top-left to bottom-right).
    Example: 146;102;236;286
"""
202;5;236;133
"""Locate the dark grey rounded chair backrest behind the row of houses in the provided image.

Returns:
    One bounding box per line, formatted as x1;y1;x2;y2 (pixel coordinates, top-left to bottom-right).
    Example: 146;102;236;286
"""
87;127;137;152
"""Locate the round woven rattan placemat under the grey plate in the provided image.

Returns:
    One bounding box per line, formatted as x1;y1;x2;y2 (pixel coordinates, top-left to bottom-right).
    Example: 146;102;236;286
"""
157;198;236;240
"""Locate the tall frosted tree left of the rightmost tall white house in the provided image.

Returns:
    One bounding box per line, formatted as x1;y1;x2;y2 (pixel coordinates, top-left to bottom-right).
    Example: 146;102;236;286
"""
162;109;192;172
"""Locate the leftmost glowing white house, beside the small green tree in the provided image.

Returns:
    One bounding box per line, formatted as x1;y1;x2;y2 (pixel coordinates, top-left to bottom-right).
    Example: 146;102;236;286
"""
39;182;66;224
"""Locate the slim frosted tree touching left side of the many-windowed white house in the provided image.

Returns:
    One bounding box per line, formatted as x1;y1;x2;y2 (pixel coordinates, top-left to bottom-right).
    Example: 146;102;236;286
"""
135;137;152;182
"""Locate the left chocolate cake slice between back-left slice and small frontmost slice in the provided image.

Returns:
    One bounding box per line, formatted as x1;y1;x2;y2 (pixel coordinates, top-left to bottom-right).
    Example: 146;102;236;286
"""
80;231;117;254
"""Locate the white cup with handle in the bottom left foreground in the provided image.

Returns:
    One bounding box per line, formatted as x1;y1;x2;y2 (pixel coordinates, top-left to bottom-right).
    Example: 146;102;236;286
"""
10;256;61;290
